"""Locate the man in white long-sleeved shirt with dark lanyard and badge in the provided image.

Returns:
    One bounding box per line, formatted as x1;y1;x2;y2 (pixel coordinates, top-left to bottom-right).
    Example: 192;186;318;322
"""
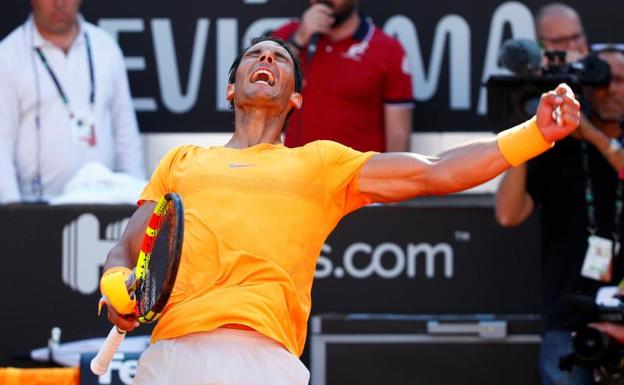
0;0;145;203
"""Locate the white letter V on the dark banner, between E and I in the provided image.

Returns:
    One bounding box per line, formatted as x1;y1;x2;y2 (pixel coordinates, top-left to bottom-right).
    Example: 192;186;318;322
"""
152;18;210;114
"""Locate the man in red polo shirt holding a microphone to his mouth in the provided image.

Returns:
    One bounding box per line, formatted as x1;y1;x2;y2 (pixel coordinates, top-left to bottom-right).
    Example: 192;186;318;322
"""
274;0;413;151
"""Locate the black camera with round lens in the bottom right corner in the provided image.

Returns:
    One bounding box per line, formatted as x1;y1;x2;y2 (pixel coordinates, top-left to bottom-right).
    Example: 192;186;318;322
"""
559;295;624;385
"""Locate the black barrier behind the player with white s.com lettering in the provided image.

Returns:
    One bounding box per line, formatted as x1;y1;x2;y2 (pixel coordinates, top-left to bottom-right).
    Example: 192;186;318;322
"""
0;197;540;365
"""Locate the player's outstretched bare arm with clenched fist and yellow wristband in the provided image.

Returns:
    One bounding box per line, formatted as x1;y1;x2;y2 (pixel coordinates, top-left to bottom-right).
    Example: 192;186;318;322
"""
358;84;580;202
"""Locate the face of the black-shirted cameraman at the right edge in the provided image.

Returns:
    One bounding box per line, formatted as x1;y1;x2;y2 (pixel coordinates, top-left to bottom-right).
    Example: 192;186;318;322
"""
590;52;624;123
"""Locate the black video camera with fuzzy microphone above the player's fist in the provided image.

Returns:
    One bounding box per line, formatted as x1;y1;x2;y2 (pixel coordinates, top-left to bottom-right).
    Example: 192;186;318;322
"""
486;39;611;130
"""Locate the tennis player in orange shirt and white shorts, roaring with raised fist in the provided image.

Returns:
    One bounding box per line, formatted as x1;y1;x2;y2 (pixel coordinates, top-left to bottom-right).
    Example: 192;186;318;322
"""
104;38;579;385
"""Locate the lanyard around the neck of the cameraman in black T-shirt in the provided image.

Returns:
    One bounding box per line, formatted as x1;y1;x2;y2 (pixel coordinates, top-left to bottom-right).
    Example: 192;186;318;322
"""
581;141;624;257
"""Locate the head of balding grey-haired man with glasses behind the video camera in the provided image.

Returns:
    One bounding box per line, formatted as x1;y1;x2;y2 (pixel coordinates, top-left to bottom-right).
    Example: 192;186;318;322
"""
535;3;589;62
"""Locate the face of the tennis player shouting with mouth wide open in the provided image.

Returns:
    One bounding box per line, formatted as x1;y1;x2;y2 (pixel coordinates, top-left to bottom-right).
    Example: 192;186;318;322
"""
228;41;295;111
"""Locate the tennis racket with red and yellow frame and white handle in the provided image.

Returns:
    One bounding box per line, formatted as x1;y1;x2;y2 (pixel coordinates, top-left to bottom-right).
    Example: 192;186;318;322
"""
91;193;184;376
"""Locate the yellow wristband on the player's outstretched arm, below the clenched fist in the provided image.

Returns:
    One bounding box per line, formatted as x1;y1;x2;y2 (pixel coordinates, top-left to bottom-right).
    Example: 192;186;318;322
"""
497;117;555;167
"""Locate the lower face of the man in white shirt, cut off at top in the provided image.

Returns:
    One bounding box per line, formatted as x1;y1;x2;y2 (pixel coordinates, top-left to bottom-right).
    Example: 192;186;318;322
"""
31;0;81;34
